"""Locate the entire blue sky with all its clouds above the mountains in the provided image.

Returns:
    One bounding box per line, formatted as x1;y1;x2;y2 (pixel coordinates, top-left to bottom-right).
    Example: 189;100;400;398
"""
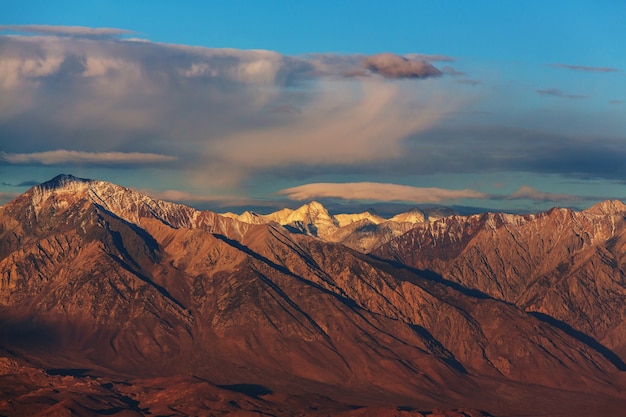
0;0;626;212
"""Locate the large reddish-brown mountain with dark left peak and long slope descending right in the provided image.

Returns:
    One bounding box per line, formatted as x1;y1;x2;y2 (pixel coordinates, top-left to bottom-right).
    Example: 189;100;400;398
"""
0;176;624;416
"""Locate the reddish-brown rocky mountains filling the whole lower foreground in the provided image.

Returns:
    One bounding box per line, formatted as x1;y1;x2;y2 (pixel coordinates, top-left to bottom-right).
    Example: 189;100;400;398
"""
0;176;626;416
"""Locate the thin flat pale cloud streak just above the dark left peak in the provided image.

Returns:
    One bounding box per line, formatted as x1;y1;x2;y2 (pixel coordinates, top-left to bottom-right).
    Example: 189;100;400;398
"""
0;149;176;165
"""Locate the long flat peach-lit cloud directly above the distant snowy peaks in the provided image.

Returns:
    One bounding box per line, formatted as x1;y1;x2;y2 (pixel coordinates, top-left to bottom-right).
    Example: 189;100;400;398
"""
276;182;487;203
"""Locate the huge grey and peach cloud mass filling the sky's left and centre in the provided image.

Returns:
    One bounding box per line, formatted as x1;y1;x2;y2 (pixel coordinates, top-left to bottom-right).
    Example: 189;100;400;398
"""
0;36;458;193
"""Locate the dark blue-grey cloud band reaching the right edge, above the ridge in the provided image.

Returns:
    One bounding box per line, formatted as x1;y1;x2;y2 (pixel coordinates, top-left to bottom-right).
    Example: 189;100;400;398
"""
268;124;626;182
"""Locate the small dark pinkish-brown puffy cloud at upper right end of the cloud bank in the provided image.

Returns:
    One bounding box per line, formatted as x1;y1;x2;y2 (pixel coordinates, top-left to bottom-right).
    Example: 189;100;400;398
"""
361;53;442;78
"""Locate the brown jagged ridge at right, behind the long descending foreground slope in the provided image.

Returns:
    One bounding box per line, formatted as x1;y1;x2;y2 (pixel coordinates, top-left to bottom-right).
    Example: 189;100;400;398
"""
374;201;626;362
